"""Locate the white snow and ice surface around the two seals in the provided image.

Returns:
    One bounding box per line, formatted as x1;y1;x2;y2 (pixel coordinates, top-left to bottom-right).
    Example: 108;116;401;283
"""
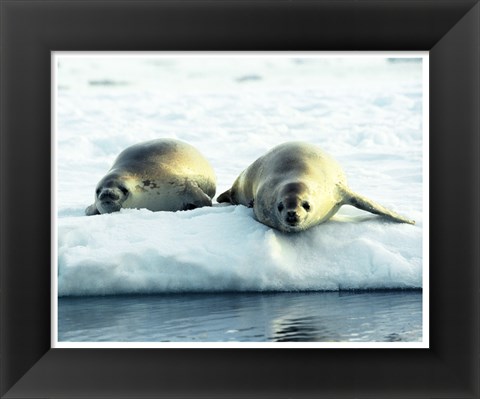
54;54;427;296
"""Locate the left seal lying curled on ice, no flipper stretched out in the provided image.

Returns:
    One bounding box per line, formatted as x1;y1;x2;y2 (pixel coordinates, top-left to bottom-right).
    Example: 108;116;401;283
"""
85;138;216;215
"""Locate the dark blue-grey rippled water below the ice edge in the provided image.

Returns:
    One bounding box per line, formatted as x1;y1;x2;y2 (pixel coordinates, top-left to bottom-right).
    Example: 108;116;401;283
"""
58;291;422;342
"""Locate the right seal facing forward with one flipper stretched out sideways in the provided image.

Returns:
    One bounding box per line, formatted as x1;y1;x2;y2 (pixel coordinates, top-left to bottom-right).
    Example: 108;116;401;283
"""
217;142;415;232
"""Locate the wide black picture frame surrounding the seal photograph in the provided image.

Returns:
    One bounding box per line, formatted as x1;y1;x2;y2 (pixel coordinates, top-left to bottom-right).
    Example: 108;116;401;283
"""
0;0;480;398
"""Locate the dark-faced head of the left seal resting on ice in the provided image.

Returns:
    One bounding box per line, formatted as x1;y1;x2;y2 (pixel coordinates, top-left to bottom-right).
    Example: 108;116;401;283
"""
95;176;130;214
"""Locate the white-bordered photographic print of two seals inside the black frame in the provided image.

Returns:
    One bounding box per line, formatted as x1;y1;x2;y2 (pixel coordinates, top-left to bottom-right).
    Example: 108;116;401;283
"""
52;52;429;348
